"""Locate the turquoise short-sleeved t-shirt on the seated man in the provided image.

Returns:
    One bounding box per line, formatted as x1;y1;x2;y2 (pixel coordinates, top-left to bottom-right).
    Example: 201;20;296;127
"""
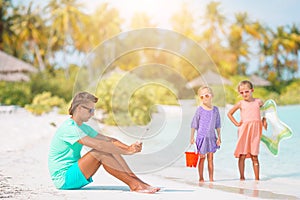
48;118;98;188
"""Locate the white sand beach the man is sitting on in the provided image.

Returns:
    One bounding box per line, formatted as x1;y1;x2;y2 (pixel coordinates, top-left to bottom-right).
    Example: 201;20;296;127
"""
0;108;300;200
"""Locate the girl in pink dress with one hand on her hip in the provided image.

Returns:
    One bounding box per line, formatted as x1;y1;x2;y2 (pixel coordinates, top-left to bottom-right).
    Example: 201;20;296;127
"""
227;80;267;180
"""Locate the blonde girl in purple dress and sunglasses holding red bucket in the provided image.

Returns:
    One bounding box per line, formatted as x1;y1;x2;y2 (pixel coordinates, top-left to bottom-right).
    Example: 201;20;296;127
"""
190;86;221;182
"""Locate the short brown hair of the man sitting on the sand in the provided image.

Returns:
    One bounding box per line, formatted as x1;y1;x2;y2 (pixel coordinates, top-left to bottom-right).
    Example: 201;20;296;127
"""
69;92;98;115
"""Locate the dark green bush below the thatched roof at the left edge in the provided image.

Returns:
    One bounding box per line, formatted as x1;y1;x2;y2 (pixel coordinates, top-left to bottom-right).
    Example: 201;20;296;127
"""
0;82;32;106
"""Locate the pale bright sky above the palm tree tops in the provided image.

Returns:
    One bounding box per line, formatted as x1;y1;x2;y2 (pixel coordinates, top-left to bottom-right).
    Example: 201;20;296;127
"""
81;0;300;28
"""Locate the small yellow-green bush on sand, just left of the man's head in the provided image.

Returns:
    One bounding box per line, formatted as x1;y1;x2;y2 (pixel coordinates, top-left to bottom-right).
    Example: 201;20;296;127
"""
25;92;66;115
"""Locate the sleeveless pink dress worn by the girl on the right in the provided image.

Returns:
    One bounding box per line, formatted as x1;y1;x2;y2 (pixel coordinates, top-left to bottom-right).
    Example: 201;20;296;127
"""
234;99;262;158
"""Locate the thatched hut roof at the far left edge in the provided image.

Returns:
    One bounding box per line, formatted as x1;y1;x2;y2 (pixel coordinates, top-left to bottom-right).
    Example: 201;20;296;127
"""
0;51;37;82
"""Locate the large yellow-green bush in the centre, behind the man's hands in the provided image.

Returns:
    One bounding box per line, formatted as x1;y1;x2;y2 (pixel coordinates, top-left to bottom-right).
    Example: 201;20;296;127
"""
96;74;178;125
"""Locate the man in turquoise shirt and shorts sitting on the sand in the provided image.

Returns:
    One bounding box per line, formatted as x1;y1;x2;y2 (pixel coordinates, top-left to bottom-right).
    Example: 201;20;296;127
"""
48;92;160;193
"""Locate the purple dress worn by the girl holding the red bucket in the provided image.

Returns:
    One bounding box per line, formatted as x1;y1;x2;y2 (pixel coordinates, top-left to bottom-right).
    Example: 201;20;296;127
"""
191;106;221;154
